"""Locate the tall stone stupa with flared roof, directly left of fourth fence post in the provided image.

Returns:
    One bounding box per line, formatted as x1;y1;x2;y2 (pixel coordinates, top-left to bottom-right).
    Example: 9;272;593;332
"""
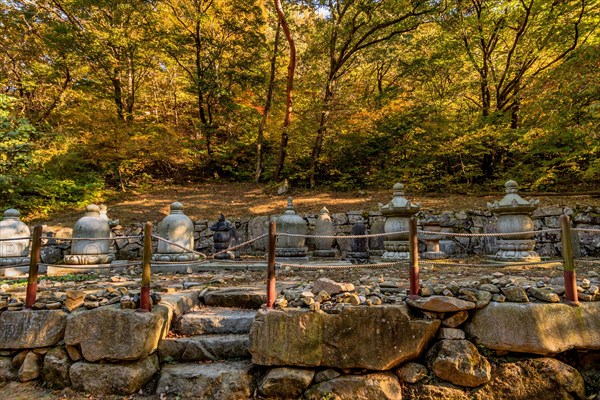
379;183;421;261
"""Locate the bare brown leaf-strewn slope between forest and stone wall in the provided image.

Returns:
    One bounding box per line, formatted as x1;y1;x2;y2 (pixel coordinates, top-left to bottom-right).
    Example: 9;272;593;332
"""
26;182;600;227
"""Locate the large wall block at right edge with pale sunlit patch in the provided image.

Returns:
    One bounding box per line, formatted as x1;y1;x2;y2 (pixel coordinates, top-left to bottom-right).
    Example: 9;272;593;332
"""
464;302;600;355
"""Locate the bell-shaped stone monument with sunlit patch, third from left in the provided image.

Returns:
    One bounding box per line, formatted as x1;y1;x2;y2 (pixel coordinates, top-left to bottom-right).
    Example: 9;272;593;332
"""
152;202;200;262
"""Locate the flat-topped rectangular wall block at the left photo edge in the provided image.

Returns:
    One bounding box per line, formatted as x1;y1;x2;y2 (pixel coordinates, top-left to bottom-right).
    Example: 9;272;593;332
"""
0;310;67;349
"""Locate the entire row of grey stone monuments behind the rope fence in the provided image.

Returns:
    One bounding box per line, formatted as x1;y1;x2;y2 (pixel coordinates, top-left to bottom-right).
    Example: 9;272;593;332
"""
0;181;540;271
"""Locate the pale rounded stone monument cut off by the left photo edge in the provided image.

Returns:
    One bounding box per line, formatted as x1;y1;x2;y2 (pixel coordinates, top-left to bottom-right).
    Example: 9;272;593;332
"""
0;208;30;276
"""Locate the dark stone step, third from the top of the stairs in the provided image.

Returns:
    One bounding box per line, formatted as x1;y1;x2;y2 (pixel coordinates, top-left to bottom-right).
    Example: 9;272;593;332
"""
158;334;250;363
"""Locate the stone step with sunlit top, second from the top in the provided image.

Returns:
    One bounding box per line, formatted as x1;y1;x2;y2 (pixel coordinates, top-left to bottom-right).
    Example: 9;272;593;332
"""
173;307;256;336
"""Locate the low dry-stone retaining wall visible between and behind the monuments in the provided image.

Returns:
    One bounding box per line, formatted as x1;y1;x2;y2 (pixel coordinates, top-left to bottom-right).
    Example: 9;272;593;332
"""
41;206;600;264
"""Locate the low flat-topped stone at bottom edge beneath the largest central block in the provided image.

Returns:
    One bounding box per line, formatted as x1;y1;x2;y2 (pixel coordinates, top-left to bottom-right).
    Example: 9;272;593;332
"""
304;372;402;400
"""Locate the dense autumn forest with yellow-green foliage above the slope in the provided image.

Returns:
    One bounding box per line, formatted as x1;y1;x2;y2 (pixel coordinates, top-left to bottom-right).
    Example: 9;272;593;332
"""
0;0;600;216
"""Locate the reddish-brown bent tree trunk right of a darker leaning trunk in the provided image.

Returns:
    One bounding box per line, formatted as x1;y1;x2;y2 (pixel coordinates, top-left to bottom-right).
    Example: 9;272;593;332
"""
274;0;296;182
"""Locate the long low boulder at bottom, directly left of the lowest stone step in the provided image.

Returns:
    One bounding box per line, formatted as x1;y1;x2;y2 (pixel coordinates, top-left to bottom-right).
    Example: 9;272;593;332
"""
69;354;159;395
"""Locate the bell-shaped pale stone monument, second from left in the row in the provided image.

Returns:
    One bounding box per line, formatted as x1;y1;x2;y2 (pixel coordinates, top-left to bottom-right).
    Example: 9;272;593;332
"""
64;204;115;265
